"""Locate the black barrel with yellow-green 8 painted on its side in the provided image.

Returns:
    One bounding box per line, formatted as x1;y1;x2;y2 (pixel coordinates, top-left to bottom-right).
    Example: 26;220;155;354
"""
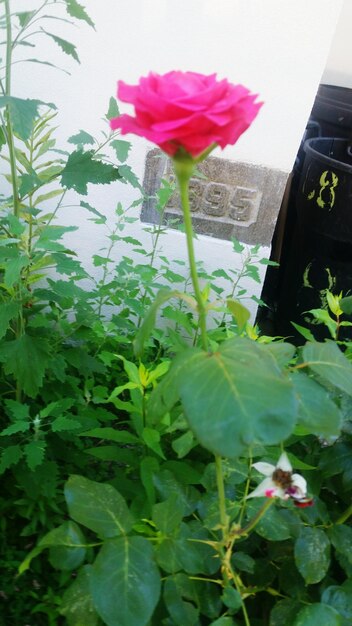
278;138;352;339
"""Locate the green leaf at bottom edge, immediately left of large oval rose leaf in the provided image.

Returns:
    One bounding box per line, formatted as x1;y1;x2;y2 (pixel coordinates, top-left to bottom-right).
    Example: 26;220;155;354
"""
60;565;99;626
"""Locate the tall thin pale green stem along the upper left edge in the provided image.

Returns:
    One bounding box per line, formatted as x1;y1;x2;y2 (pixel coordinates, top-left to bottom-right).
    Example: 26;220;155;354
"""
4;0;20;217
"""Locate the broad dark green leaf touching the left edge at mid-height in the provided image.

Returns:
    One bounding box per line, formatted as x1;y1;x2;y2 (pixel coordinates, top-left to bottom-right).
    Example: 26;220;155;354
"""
0;335;50;398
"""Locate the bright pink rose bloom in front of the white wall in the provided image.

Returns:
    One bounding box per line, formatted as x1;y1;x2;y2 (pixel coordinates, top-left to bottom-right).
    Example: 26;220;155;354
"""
110;72;262;157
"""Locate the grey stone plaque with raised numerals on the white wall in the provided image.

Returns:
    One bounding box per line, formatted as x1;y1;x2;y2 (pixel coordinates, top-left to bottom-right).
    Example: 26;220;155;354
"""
141;149;288;245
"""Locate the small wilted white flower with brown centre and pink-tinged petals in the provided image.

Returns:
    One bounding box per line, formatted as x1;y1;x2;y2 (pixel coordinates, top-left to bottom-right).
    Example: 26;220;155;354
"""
247;452;312;506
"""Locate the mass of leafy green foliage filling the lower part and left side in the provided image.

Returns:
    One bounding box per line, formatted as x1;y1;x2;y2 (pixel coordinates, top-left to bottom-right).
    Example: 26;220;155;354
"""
0;0;352;626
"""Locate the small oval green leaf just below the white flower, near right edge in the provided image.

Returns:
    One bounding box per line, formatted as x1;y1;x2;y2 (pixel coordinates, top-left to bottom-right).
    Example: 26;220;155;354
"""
295;526;330;585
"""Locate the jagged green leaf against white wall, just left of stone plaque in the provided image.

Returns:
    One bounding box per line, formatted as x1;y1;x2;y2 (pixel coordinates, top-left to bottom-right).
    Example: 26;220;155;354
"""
61;150;122;195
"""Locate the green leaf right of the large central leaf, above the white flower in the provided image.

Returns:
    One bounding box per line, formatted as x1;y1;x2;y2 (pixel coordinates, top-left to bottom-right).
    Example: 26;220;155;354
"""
291;372;342;437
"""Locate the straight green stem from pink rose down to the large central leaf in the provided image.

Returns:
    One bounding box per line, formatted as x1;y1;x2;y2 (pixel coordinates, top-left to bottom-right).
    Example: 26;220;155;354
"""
174;160;208;350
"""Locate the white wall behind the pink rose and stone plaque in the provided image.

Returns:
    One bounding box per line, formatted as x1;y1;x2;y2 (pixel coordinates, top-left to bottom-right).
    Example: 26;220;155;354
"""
8;0;342;316
